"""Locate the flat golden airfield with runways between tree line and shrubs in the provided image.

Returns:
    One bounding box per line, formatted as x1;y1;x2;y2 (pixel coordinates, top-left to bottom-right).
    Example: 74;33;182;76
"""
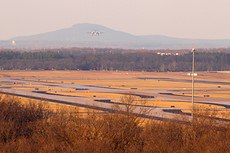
0;71;230;120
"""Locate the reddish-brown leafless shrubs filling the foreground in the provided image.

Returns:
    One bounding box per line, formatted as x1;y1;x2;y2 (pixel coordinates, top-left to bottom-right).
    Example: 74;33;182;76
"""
0;96;230;153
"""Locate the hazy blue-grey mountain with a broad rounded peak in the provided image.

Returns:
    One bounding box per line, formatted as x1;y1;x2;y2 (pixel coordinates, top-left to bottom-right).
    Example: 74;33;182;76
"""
0;23;230;49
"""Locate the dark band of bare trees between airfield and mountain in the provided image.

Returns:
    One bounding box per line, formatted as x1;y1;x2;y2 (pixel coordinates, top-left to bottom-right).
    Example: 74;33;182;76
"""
0;49;230;72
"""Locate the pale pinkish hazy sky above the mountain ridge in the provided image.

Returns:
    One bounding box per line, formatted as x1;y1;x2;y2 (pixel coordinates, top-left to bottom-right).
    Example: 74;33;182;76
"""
0;0;230;40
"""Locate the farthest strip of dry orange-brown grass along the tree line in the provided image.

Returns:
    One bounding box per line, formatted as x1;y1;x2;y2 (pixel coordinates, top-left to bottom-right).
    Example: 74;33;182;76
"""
0;71;230;82
